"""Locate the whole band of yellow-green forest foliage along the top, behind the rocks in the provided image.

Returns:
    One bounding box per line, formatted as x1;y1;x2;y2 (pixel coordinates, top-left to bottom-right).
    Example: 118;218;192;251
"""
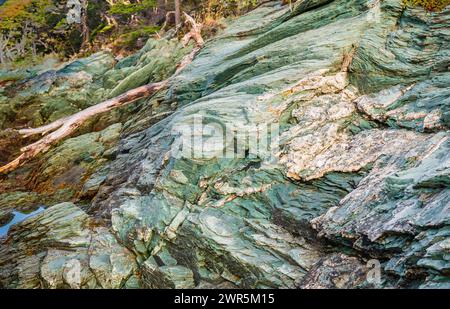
0;0;262;65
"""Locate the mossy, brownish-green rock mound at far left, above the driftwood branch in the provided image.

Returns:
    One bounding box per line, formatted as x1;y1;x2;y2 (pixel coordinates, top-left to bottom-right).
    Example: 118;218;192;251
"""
0;53;115;129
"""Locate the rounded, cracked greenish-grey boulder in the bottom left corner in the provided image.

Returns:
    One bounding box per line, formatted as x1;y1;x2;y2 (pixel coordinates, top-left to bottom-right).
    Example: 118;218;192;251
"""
0;203;136;288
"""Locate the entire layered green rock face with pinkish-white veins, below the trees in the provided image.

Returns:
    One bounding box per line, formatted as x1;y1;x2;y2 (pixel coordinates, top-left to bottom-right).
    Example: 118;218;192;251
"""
0;0;450;288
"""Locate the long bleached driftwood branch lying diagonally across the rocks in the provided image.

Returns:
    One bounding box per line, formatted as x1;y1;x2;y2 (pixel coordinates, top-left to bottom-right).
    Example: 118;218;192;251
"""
0;13;204;173
